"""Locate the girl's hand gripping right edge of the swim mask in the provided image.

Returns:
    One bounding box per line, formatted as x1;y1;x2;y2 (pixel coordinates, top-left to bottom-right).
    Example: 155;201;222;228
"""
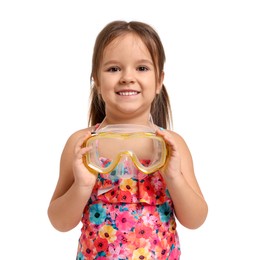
156;129;181;179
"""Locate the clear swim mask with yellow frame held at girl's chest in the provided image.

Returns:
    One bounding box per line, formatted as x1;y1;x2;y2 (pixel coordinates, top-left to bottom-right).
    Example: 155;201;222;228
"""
83;124;168;176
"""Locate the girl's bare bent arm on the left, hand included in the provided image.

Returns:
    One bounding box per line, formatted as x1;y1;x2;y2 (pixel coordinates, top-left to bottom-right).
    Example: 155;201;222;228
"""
48;130;96;232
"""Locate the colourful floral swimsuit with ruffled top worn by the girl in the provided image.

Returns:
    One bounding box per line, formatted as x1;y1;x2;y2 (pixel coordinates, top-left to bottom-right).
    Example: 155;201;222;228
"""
76;146;180;260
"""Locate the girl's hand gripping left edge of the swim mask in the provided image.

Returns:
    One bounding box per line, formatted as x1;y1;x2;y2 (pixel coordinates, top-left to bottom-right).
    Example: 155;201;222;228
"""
72;132;97;187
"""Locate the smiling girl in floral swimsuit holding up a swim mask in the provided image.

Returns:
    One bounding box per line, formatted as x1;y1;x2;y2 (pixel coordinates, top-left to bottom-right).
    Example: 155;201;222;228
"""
48;21;208;260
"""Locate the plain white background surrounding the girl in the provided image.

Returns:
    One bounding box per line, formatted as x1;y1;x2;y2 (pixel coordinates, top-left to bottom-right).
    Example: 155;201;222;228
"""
0;0;263;260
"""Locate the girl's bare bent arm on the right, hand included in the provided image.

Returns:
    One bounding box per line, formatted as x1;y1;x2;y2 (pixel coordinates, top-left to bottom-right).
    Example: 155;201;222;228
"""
157;130;208;229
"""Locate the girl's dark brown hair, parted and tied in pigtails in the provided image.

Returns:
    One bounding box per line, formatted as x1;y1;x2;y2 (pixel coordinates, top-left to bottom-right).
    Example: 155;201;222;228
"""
89;21;172;128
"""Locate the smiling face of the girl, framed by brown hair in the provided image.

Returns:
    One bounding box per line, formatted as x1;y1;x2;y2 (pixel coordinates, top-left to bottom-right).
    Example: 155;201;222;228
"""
96;33;163;122
